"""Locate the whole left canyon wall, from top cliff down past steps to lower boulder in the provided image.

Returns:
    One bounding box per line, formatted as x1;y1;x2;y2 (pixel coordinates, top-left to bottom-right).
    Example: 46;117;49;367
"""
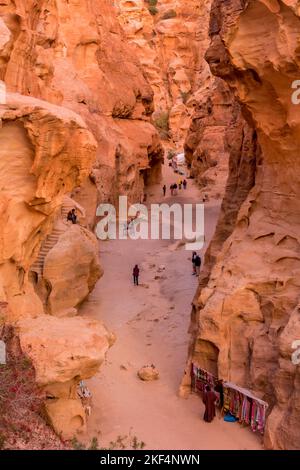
0;0;163;438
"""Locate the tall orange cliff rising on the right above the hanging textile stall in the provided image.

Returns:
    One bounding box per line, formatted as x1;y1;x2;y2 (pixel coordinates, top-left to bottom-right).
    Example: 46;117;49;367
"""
184;0;300;449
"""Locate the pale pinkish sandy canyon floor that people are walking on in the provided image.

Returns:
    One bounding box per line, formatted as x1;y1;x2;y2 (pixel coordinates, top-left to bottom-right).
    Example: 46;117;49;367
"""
81;166;260;449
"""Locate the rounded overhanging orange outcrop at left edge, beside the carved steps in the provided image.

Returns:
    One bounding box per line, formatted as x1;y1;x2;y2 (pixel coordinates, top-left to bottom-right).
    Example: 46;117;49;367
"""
0;93;96;318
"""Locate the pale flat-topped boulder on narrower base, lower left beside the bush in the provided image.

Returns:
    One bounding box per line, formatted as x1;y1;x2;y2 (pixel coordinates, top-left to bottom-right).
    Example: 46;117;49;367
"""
17;315;114;439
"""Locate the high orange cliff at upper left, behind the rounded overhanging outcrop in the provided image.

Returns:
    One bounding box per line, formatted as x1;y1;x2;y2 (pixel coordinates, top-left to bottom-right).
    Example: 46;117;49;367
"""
0;0;162;215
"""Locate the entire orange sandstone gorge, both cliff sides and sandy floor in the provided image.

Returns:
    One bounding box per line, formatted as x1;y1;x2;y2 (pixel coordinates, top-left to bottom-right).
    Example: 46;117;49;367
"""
0;0;300;450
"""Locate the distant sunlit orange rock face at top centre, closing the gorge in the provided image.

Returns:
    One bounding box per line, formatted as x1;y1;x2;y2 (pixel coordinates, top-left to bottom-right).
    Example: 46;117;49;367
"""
115;0;211;149
